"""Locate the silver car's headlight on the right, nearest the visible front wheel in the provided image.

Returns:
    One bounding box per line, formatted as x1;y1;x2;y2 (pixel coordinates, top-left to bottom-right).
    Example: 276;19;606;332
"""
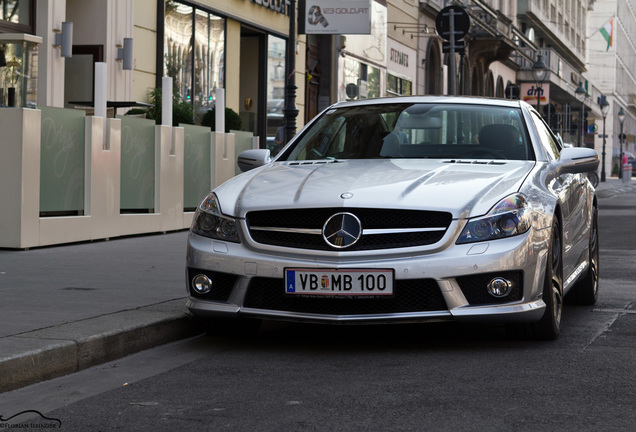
457;194;532;244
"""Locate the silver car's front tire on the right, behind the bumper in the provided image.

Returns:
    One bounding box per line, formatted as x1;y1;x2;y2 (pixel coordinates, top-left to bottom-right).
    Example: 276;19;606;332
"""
508;218;563;340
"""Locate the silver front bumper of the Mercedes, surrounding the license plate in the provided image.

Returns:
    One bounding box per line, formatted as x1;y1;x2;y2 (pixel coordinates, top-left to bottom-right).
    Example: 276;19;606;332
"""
186;229;547;323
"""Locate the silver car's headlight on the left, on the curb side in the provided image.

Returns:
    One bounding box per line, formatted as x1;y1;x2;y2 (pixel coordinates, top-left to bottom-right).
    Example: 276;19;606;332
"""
190;193;241;243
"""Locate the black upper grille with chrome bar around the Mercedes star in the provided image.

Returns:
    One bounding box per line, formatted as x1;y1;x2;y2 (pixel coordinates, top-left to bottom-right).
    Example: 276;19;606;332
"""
246;208;452;251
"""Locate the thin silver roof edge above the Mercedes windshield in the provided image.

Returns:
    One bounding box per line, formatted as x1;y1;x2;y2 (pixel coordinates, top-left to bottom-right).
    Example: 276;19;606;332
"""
331;96;530;108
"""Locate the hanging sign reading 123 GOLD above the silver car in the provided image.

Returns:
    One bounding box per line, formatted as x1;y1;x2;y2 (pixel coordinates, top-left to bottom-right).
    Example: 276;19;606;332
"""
300;0;371;34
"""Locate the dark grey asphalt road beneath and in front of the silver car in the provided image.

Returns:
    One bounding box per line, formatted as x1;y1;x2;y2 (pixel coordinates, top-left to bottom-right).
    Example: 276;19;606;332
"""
0;186;636;431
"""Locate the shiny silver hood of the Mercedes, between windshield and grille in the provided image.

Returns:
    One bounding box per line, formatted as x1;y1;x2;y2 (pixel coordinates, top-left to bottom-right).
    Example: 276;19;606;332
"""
215;159;535;218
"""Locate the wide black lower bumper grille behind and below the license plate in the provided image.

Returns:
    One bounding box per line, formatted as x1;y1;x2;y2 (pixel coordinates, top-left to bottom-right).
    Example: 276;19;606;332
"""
243;277;448;315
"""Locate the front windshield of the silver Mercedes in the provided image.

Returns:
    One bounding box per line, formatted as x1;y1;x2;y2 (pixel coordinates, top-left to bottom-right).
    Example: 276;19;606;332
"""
278;103;534;161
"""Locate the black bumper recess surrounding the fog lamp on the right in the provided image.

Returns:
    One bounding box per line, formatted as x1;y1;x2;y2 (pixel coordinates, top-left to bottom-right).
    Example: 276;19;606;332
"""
455;271;523;306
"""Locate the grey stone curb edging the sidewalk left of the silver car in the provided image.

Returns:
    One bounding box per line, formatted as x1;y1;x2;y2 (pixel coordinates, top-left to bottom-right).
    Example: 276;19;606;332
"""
0;298;200;393
